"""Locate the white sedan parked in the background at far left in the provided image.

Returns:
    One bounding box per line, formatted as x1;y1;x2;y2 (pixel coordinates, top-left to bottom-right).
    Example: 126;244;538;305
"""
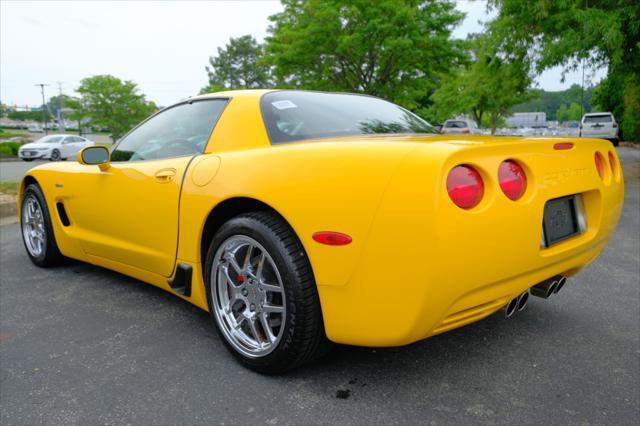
18;135;95;161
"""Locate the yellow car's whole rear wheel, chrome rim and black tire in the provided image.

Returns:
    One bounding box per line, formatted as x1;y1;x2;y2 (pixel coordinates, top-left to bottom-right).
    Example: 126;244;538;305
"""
205;212;330;374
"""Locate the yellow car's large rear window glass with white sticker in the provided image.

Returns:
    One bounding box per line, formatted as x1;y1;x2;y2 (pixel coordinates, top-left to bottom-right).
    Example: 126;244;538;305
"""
260;91;438;144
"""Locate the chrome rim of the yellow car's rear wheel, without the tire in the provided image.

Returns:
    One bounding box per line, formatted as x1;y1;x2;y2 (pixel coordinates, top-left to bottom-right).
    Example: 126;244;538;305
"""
211;235;287;358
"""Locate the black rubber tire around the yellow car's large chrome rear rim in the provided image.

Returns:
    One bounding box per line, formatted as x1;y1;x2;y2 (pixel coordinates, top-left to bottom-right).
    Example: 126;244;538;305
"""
205;212;331;374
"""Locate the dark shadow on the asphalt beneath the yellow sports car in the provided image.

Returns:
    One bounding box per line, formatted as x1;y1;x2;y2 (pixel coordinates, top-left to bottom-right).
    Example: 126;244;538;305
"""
57;253;579;386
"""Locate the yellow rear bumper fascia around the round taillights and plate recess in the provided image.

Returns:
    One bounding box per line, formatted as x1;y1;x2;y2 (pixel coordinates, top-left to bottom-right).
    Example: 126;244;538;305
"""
318;141;624;346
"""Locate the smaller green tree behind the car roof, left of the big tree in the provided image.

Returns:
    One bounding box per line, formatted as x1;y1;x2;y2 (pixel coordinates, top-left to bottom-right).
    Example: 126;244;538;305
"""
200;35;272;93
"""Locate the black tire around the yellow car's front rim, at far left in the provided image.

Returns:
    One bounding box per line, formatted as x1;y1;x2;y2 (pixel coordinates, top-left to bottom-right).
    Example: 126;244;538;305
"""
20;183;65;268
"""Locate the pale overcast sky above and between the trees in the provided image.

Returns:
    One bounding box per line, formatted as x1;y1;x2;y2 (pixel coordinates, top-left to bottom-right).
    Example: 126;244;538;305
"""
0;0;604;105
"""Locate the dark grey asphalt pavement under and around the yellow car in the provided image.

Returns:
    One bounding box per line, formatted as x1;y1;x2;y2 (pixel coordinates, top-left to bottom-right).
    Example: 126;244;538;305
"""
0;148;640;425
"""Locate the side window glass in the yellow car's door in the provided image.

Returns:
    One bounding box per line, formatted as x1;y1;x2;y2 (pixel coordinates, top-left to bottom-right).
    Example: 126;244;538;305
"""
111;99;227;161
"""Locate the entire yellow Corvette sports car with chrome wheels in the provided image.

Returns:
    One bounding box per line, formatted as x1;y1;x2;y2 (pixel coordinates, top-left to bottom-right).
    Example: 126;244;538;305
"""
19;91;624;373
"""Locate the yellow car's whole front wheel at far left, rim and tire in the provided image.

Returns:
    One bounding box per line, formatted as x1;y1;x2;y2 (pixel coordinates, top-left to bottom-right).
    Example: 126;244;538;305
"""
20;183;64;267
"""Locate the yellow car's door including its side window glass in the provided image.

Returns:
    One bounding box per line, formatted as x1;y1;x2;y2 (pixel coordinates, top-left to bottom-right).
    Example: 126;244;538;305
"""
65;99;227;276
